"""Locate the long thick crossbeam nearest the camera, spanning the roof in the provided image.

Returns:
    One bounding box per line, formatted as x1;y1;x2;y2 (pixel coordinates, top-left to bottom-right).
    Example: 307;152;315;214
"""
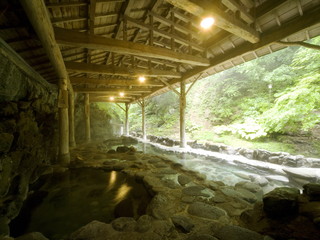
55;28;209;66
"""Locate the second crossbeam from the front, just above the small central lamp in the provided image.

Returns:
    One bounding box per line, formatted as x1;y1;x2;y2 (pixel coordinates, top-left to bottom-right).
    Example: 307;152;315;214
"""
65;62;181;78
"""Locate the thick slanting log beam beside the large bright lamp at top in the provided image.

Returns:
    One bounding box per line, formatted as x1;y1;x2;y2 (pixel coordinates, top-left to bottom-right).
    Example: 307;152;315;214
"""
166;0;260;43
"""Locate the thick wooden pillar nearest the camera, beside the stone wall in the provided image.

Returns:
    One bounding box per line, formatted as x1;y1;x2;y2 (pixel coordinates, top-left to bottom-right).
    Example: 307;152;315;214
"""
58;78;70;165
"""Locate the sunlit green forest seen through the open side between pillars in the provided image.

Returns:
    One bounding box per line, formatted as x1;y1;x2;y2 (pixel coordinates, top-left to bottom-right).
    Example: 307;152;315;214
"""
100;34;320;157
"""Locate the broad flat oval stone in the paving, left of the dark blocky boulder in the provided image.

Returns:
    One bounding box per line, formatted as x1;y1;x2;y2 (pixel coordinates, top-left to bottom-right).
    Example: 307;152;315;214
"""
188;202;227;220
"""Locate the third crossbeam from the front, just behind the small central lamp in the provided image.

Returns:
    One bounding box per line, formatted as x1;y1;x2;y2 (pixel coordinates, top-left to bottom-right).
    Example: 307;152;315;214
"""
70;77;163;87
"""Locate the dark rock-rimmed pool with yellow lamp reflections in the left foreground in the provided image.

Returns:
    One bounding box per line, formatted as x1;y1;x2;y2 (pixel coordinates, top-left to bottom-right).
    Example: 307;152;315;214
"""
10;168;151;240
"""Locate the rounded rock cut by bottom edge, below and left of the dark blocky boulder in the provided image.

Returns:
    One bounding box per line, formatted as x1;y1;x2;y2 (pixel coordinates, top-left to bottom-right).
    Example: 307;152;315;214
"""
215;225;264;240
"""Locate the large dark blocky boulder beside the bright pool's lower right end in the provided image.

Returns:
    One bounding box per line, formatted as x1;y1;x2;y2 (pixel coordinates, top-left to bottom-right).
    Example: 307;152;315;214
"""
263;187;300;218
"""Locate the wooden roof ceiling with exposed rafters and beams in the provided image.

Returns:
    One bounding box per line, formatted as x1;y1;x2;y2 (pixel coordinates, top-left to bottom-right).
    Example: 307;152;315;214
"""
0;0;320;102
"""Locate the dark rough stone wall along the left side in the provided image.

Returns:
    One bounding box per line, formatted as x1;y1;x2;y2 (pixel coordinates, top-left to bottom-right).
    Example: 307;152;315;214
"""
0;41;58;237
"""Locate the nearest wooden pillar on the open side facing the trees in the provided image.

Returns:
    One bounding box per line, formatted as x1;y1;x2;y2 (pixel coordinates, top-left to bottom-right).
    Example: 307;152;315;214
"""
180;81;187;148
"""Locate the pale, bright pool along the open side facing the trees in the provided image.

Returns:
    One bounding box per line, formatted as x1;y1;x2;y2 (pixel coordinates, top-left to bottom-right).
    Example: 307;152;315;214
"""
127;142;302;193
